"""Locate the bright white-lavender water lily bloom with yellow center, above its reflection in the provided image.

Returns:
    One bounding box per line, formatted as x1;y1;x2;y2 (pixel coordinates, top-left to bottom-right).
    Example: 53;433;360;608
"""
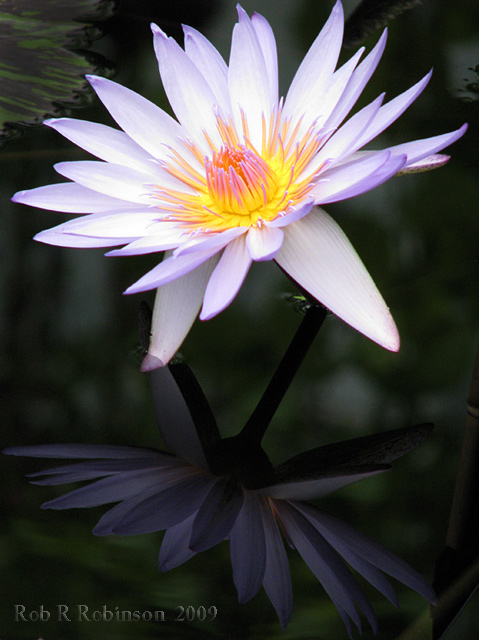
13;1;466;370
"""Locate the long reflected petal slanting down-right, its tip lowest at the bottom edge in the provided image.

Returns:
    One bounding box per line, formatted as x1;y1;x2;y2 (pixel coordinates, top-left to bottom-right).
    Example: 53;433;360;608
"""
278;503;377;633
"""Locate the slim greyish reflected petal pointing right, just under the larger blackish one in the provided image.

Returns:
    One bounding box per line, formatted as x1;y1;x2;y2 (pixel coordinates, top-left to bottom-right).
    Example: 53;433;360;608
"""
258;469;387;500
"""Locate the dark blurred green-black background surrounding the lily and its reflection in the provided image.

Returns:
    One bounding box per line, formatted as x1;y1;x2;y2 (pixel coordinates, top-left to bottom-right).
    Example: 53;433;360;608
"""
0;0;479;640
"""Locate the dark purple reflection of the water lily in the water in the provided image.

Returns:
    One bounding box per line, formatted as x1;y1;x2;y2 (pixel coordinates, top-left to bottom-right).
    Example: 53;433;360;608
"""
4;365;435;637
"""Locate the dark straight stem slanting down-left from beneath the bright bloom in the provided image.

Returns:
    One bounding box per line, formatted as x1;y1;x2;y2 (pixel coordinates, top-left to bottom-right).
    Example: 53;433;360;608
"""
238;304;327;445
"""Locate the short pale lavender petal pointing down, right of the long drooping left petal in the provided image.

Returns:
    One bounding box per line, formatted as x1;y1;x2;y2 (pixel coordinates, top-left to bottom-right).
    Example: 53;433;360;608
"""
200;236;251;320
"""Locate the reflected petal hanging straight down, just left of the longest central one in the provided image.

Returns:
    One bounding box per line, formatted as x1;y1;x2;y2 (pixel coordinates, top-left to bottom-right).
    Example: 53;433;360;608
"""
230;491;266;604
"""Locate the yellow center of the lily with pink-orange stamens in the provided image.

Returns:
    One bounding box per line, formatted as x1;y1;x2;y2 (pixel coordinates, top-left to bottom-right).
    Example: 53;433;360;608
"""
156;110;322;232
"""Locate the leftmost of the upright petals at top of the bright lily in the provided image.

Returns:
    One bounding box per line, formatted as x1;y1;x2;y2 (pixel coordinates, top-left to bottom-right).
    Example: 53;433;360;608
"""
151;24;221;153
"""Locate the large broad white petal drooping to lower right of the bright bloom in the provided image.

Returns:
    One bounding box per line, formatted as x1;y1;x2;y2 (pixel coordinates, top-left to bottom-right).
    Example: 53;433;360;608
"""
276;208;399;351
